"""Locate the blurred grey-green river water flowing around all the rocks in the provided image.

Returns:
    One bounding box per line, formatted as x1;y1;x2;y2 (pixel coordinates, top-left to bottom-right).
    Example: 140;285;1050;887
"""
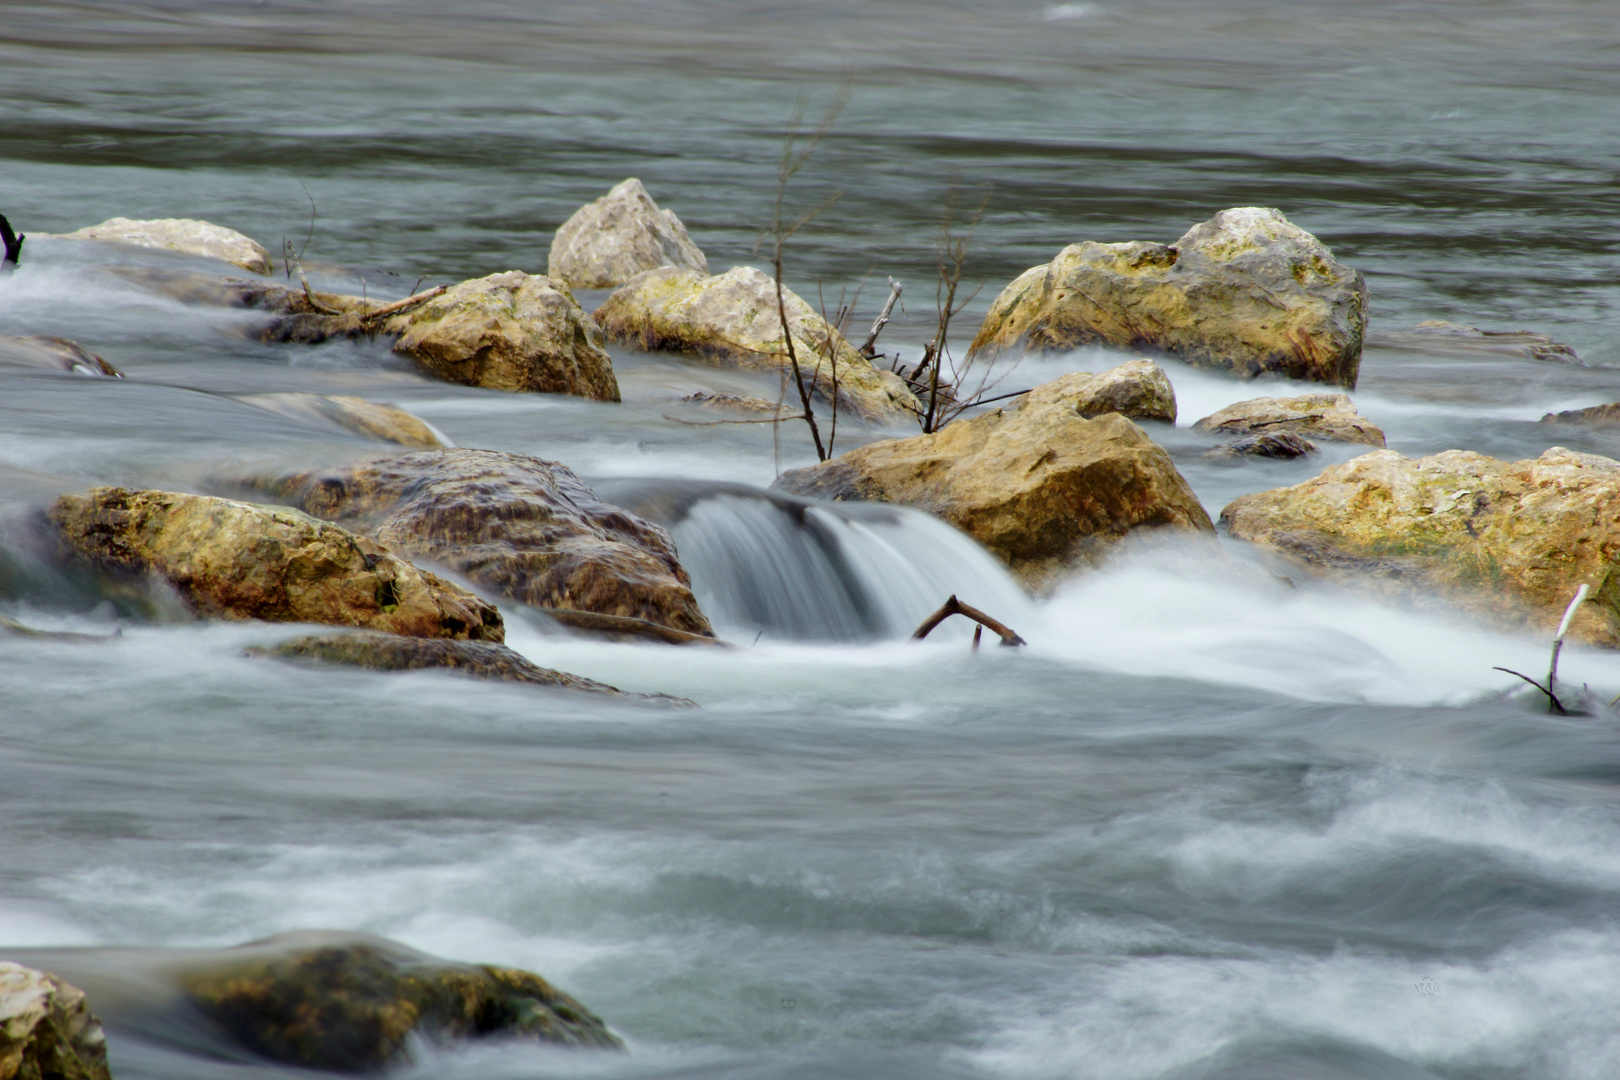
0;0;1620;1080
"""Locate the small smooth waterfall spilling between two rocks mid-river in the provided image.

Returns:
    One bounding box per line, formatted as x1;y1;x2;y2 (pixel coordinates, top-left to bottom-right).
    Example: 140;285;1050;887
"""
596;479;1030;641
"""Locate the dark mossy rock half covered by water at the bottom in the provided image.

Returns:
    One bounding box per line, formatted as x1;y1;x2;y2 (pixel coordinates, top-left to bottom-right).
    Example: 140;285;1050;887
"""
180;934;624;1074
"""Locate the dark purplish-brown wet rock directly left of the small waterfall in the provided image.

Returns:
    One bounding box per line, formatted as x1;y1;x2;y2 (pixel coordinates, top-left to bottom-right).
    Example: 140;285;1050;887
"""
247;450;713;638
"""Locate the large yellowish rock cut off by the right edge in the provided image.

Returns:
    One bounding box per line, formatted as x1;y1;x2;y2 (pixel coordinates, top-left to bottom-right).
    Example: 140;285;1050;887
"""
1221;447;1620;648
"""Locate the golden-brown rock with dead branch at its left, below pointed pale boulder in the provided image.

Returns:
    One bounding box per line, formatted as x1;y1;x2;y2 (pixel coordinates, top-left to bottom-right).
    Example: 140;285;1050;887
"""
384;270;619;402
